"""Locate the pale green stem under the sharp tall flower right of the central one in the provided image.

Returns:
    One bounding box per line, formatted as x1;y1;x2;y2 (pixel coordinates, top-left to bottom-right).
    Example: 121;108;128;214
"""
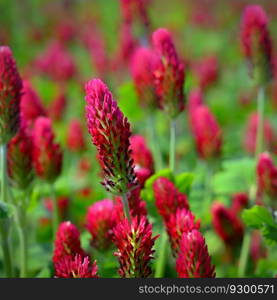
147;114;163;171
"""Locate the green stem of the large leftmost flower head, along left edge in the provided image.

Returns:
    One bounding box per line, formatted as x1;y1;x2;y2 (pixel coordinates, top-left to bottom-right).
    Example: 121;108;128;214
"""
0;145;13;277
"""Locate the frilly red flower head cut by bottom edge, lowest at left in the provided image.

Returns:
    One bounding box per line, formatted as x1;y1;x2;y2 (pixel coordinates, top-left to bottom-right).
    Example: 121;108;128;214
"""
55;254;98;278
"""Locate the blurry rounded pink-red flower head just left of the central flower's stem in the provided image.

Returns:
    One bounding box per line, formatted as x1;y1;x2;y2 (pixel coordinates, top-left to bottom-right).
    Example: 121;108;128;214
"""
86;199;115;250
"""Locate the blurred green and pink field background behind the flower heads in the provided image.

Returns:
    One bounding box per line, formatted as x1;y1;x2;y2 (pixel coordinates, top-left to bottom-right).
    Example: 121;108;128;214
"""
0;0;277;277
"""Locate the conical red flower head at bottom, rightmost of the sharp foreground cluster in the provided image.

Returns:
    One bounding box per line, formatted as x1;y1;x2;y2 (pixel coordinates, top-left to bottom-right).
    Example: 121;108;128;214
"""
176;229;216;278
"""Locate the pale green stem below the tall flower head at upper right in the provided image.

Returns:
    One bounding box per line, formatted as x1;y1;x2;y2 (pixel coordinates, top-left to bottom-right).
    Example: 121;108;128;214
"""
255;86;265;160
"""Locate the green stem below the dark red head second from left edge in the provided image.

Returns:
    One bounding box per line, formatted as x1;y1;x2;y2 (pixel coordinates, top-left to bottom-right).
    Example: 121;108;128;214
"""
16;206;28;278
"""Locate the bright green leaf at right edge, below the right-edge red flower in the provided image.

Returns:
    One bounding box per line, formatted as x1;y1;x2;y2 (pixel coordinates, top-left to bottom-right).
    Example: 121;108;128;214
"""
242;205;277;229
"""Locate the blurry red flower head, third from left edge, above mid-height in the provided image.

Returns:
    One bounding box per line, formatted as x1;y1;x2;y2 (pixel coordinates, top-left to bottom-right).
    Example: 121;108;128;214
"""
33;117;63;182
